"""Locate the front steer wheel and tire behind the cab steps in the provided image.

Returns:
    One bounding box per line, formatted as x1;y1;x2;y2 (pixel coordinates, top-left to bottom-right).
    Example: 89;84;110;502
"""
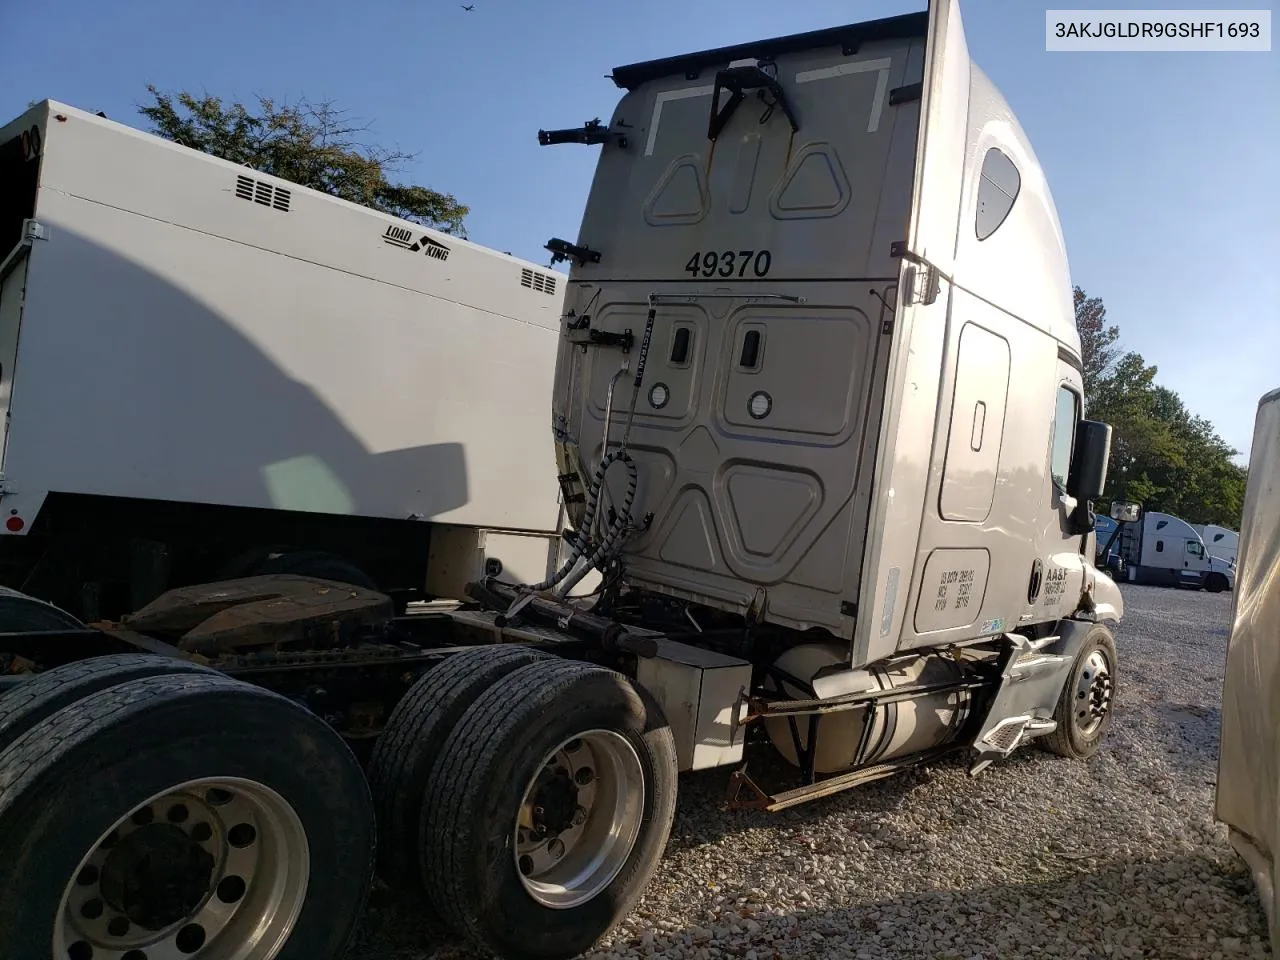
1036;623;1116;760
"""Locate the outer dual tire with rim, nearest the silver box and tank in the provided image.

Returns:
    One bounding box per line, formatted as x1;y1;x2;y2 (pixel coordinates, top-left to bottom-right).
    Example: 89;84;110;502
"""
420;659;677;960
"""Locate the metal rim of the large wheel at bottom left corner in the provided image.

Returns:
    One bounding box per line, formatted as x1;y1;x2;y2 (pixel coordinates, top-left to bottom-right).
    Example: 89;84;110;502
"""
54;777;310;960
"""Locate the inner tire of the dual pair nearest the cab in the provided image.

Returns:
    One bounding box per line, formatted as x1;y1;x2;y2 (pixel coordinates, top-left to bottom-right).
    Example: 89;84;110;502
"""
369;644;550;893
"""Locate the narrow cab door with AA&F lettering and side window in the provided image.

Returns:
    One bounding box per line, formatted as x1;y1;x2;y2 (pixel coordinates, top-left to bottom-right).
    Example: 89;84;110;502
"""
1027;360;1087;621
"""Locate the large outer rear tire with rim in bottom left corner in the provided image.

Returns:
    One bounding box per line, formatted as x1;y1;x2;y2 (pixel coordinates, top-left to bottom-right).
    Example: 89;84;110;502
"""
0;673;374;960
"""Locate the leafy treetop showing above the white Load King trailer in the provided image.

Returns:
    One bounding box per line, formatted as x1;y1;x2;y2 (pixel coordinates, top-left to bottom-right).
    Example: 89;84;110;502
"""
138;83;468;237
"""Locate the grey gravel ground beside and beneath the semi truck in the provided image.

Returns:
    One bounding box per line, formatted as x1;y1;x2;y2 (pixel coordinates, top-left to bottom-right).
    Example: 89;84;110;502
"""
347;586;1271;960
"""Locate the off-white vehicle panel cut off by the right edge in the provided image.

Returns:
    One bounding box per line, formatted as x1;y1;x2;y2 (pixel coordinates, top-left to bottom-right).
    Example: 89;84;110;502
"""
1215;389;1280;952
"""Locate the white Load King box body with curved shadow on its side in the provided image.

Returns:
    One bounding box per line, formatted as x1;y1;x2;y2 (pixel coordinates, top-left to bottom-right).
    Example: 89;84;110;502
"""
0;101;581;617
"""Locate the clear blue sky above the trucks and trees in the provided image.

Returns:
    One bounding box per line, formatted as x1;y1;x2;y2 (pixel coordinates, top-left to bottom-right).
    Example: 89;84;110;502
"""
0;0;1280;461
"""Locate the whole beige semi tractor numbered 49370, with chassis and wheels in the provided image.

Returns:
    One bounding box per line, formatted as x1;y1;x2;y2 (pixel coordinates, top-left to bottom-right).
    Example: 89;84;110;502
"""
0;0;1123;960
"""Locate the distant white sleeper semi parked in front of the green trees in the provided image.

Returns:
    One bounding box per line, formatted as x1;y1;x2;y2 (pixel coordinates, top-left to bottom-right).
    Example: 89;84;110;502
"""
1102;511;1235;593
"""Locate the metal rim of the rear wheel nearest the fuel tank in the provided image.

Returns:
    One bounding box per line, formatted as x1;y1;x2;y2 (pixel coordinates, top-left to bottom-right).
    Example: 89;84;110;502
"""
513;730;645;910
